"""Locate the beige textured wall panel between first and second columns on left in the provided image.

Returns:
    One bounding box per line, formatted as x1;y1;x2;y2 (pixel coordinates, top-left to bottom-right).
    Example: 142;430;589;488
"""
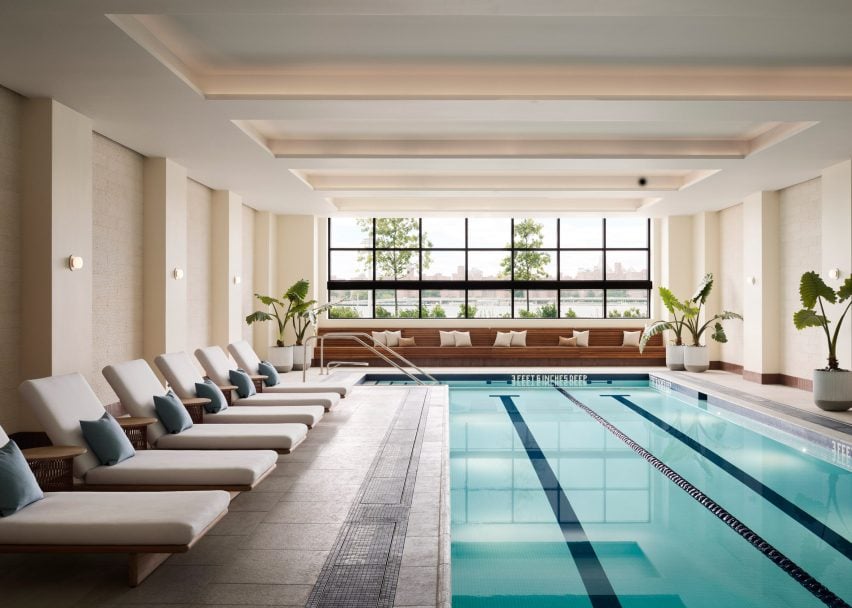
89;133;144;403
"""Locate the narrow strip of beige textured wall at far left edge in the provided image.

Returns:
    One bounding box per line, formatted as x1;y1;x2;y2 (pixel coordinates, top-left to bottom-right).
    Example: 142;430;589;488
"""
0;87;24;432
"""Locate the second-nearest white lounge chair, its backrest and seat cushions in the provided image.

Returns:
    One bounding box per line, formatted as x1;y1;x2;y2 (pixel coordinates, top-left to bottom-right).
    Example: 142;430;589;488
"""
19;374;278;492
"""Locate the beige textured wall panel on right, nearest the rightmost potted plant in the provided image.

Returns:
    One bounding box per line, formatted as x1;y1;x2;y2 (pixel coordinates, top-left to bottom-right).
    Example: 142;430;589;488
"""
779;179;826;378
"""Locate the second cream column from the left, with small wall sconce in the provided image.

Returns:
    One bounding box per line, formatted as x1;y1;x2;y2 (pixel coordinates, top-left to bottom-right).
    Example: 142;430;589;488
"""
143;158;187;363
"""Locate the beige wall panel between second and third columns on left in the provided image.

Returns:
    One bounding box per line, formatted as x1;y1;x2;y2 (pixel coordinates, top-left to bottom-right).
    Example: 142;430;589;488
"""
186;180;213;354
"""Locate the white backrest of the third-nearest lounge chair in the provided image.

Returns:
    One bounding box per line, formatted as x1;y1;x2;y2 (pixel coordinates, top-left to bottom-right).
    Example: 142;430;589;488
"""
103;359;166;445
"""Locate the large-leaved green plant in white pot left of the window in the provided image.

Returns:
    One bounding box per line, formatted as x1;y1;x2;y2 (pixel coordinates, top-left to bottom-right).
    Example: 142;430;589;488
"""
246;279;329;372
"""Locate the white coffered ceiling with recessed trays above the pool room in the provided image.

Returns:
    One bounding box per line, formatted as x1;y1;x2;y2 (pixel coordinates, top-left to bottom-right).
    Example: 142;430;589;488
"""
0;0;852;215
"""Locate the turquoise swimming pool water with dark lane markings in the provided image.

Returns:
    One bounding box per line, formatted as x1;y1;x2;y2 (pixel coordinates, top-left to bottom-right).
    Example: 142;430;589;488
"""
450;381;852;608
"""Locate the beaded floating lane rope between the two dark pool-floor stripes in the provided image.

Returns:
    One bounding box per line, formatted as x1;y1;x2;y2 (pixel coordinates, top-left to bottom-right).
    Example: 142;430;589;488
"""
553;385;852;608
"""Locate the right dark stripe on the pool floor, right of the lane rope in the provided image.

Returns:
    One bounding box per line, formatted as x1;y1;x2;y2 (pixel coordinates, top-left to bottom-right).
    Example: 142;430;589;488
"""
601;395;852;560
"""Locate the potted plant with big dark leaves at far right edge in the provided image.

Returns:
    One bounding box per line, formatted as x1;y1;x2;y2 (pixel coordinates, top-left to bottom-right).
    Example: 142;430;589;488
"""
793;271;852;412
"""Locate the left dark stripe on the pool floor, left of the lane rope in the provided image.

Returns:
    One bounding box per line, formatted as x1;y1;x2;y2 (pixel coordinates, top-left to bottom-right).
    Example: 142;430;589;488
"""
491;395;621;608
